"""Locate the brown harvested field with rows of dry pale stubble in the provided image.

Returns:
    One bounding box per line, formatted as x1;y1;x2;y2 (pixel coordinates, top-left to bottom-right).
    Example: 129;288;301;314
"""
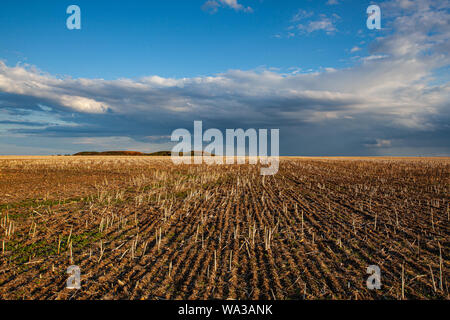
0;157;450;299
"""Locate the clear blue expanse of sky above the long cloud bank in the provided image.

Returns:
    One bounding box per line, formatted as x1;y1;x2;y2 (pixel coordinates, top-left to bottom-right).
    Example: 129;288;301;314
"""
0;0;373;79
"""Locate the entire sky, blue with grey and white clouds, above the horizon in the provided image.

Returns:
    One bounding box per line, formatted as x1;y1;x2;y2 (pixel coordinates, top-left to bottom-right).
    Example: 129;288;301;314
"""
0;0;450;156
